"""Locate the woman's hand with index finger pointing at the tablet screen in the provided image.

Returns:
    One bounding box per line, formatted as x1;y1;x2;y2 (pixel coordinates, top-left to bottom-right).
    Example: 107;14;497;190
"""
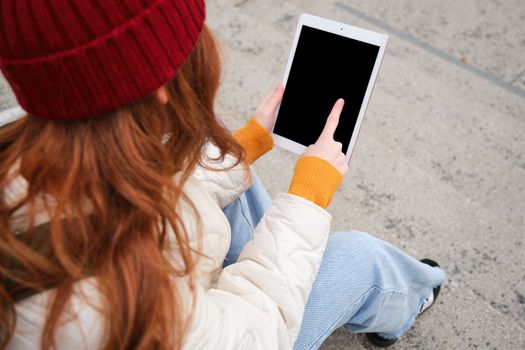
302;98;348;175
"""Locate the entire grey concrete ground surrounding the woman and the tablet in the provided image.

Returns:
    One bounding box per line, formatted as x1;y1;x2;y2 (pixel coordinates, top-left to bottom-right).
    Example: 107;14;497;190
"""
0;0;525;350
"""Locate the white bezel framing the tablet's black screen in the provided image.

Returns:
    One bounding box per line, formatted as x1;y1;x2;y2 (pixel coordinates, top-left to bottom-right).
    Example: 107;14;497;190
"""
272;13;388;162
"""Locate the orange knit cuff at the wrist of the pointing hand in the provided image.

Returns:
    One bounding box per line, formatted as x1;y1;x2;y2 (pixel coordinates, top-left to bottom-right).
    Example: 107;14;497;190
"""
288;156;343;208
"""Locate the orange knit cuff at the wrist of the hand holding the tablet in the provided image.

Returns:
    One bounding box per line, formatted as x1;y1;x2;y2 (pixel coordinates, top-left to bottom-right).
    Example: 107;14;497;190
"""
233;117;273;164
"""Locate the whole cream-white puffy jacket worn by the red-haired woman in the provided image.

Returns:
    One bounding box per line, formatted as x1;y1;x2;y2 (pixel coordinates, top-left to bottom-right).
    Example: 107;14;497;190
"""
6;140;331;350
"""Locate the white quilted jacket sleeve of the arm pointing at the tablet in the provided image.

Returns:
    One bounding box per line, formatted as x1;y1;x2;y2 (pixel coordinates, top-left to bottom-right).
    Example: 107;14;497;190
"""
188;193;331;349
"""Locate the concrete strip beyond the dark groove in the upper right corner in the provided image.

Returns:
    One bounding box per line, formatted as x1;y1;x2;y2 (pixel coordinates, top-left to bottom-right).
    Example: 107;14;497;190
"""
291;0;525;93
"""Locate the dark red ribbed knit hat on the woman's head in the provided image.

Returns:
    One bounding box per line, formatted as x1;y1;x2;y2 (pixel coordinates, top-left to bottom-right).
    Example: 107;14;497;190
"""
0;0;205;119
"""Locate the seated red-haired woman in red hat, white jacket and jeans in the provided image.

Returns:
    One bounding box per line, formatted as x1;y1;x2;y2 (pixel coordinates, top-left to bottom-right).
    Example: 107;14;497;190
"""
0;0;445;349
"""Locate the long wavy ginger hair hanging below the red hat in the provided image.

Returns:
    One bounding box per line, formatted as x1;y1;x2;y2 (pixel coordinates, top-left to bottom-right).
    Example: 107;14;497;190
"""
0;26;247;349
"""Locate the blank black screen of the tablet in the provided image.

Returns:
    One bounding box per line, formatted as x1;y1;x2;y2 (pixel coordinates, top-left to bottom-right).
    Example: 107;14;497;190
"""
273;26;379;153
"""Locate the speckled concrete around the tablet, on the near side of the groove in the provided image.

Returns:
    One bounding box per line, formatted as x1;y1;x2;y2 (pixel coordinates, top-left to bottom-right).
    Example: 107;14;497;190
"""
209;0;525;348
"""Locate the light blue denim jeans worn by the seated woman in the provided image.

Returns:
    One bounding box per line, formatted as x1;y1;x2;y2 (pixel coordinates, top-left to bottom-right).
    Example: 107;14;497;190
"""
224;172;446;350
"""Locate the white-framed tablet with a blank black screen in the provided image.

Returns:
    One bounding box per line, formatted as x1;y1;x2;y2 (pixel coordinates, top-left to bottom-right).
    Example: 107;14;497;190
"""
272;14;388;162
